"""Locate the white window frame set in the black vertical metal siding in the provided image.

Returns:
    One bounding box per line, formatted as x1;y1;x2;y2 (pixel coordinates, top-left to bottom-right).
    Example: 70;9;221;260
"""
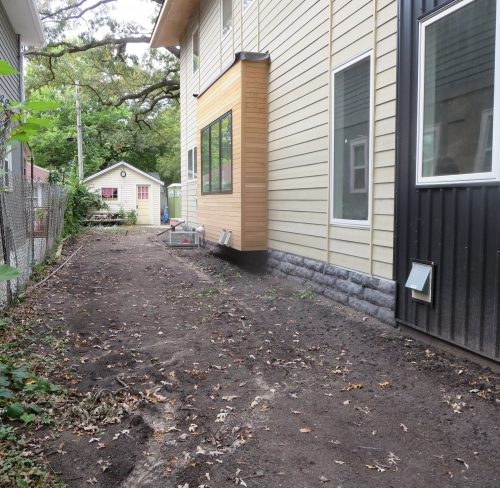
416;0;500;186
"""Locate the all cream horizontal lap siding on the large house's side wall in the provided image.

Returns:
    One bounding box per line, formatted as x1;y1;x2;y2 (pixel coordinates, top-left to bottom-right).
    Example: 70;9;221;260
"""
178;0;397;278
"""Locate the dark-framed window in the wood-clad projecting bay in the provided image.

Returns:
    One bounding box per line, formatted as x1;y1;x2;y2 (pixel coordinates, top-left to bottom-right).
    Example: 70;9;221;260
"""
201;112;233;194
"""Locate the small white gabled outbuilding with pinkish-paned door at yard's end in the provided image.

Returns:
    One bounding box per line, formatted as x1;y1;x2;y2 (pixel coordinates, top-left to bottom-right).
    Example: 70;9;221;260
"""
83;162;163;225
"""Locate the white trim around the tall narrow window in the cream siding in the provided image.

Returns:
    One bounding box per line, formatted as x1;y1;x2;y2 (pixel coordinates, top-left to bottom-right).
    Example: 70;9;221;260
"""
330;50;374;229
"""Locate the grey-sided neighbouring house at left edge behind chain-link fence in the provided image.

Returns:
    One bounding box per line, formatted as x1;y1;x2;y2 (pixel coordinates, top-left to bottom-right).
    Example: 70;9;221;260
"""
0;0;45;176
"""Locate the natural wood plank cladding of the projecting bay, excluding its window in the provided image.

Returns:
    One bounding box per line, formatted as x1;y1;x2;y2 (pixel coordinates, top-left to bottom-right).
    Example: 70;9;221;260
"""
197;57;268;251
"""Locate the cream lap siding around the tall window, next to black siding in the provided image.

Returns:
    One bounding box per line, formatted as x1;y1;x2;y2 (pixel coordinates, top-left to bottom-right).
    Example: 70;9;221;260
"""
330;0;397;279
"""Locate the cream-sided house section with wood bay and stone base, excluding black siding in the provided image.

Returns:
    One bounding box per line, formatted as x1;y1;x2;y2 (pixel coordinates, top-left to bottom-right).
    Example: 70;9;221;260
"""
151;0;398;323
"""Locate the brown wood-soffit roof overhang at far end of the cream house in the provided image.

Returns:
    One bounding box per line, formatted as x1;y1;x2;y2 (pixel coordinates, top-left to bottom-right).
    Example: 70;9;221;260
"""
149;0;200;47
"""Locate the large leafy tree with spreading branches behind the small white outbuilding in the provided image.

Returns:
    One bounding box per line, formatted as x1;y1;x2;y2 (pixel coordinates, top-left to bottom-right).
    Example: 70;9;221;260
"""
26;0;180;183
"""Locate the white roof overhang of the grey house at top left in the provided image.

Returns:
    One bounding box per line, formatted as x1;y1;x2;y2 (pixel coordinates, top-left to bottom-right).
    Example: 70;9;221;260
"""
0;0;45;47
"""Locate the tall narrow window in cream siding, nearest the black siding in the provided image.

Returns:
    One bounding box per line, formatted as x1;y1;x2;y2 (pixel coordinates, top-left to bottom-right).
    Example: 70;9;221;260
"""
333;55;370;225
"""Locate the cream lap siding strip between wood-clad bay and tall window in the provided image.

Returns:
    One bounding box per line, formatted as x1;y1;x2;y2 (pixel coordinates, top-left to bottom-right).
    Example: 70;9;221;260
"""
260;0;329;260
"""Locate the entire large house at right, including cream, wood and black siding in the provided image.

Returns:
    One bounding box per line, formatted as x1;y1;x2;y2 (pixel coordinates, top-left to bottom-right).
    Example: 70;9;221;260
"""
151;0;500;360
